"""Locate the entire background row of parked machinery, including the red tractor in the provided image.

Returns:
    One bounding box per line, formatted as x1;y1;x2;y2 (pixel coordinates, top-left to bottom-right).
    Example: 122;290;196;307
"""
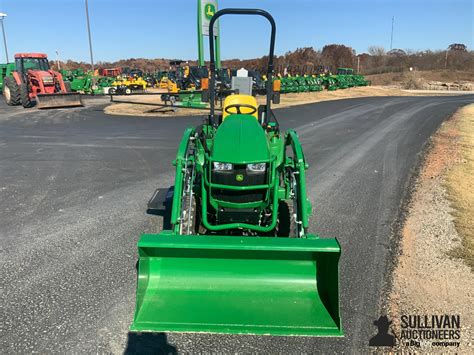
0;53;370;108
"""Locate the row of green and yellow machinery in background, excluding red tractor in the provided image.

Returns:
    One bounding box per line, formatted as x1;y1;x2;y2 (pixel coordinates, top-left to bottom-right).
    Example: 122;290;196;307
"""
61;62;370;95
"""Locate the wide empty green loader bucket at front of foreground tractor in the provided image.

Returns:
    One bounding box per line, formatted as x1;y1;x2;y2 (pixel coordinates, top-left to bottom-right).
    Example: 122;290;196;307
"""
130;231;343;336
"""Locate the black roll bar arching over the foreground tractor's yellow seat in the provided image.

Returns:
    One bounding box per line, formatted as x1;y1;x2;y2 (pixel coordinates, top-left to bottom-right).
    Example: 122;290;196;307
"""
209;9;276;125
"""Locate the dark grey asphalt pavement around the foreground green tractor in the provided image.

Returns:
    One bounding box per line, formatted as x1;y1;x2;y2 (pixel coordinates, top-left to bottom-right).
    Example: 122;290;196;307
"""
0;96;474;353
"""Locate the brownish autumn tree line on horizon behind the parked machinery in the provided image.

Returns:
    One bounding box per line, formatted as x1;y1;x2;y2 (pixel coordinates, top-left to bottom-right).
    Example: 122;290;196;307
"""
51;43;474;74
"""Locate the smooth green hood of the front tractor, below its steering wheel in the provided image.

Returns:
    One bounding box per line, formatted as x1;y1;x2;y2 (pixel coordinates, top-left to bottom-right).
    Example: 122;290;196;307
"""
211;115;270;164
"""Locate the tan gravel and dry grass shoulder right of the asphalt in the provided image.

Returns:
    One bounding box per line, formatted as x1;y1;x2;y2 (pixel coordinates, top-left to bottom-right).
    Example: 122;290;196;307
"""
389;105;474;353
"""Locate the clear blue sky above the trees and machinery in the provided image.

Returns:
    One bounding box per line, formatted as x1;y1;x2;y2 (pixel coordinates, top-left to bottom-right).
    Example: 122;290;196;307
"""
0;0;474;63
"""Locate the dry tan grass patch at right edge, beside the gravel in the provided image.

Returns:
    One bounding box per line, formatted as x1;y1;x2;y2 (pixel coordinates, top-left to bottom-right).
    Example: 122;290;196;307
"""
446;104;474;271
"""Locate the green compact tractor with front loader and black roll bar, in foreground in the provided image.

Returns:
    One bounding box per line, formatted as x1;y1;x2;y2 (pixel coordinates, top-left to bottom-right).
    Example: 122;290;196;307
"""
130;9;343;336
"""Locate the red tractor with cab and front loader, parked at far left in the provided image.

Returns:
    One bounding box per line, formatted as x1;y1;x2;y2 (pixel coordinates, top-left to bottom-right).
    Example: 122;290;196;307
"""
3;53;82;108
